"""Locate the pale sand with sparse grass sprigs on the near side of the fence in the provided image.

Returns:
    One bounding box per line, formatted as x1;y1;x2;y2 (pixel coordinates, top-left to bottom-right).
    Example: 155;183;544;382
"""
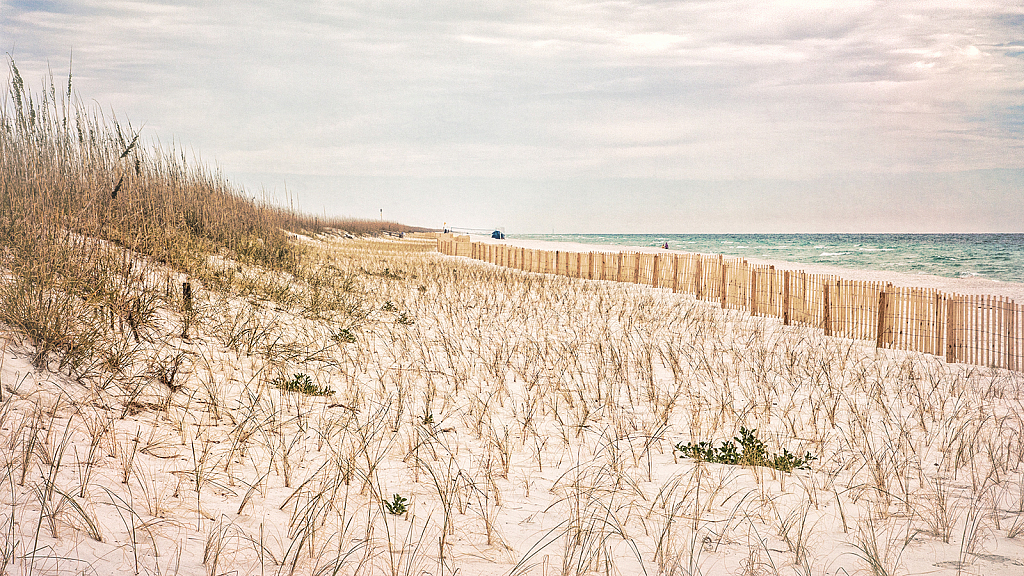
0;234;1024;576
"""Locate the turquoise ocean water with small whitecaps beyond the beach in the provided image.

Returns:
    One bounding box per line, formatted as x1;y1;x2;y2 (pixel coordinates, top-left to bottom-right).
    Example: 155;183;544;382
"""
508;234;1024;283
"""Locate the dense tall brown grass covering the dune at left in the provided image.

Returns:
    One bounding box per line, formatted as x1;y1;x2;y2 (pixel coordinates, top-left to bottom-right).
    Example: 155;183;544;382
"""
0;60;413;371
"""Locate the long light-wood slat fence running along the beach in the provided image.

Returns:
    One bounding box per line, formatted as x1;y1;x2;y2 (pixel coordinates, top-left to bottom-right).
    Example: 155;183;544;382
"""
437;234;1024;371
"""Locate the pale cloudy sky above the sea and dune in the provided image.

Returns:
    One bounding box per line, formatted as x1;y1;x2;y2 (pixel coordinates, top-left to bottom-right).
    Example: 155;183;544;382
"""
0;0;1024;234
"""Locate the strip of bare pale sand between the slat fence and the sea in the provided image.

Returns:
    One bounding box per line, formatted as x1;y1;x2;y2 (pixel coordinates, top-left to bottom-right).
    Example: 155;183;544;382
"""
468;235;1024;302
